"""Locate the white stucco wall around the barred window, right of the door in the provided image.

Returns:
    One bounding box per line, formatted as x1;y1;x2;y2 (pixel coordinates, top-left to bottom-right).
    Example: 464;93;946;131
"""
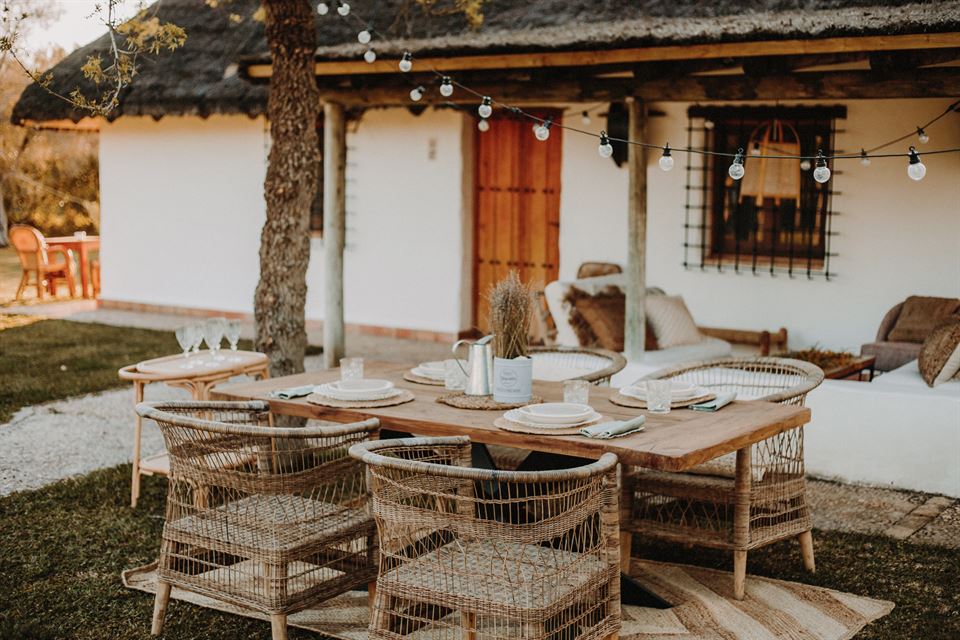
560;99;960;351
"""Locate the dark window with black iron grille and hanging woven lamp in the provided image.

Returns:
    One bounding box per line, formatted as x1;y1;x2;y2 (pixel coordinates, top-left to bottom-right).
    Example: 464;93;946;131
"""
684;105;846;279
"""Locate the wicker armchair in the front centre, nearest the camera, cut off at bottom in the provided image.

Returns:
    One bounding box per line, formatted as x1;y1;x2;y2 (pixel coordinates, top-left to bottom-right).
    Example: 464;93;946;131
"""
350;437;620;640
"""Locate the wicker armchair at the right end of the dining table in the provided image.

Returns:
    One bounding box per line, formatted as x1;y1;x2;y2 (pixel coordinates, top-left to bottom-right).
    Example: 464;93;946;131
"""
621;358;823;598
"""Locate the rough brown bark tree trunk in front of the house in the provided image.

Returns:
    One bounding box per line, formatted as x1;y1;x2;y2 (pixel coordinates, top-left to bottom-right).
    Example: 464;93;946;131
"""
254;0;320;376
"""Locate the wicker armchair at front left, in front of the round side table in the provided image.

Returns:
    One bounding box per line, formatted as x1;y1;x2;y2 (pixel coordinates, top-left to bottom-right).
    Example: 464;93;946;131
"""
137;402;379;640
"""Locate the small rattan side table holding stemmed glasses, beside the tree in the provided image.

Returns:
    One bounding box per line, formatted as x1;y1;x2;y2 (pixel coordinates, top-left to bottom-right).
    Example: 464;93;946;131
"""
118;351;270;507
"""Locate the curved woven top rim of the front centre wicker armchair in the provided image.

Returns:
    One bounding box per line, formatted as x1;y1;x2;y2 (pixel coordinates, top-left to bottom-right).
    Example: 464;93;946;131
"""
350;436;617;483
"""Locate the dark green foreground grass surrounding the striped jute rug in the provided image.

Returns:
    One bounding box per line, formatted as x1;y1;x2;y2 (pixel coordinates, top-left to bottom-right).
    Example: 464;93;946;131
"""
0;465;960;640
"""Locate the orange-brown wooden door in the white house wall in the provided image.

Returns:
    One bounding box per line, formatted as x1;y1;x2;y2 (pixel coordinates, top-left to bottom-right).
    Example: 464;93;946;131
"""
473;111;563;332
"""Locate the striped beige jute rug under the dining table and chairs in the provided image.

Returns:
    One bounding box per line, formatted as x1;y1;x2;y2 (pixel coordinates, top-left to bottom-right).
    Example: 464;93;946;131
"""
123;560;894;640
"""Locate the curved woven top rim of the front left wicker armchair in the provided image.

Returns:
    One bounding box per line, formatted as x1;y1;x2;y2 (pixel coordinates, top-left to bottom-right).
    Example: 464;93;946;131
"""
137;400;380;439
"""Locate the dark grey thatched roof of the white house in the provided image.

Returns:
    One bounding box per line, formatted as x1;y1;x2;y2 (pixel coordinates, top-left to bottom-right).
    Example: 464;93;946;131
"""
13;0;960;122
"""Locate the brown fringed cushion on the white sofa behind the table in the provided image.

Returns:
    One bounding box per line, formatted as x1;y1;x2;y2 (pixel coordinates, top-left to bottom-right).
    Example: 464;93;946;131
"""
564;285;657;351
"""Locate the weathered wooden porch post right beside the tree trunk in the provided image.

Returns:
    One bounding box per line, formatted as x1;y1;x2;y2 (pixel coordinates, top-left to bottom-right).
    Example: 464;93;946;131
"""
323;102;347;368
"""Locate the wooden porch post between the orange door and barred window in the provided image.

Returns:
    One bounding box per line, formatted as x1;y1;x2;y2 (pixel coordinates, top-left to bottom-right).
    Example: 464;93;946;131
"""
624;99;647;361
